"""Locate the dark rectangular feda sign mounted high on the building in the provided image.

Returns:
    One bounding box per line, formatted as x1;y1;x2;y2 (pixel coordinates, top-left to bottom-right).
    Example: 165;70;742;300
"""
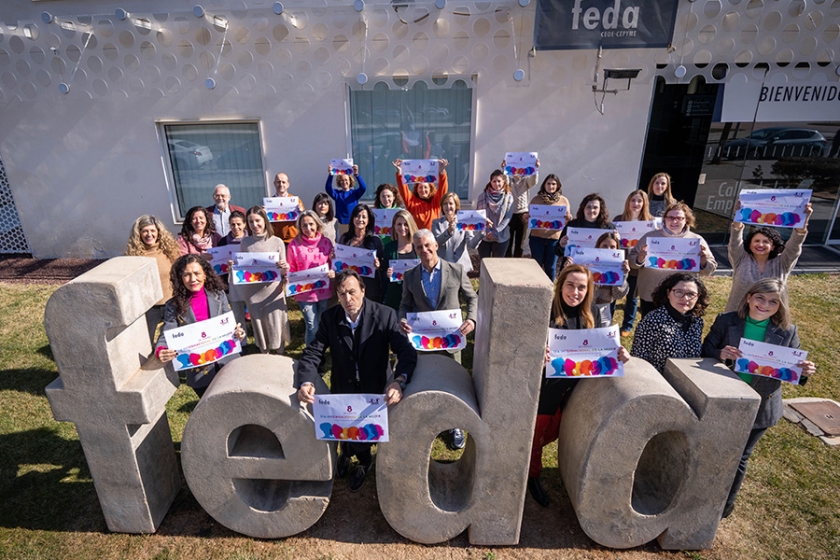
535;0;677;49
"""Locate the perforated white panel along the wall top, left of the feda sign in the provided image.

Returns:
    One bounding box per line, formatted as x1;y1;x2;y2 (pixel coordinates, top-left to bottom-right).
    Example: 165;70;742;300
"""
0;0;534;102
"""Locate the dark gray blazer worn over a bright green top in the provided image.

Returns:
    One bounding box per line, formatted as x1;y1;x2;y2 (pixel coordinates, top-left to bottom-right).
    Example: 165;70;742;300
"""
702;311;799;429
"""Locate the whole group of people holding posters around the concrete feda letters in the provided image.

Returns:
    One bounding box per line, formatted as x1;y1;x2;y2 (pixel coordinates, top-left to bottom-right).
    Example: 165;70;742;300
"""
127;164;815;510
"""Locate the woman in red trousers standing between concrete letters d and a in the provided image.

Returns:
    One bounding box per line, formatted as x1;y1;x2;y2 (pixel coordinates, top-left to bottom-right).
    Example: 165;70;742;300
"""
528;264;630;507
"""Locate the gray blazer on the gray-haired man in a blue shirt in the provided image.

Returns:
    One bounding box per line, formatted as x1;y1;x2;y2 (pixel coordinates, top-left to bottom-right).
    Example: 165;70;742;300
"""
400;259;478;322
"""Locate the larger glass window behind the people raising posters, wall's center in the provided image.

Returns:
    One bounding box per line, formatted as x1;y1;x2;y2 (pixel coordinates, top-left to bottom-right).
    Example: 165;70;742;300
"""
348;80;473;199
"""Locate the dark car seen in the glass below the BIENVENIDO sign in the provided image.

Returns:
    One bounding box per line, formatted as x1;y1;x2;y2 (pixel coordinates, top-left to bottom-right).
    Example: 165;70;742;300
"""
723;126;827;159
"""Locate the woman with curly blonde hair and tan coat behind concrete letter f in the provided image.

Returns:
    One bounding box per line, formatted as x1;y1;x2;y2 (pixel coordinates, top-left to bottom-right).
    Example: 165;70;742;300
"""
125;214;180;340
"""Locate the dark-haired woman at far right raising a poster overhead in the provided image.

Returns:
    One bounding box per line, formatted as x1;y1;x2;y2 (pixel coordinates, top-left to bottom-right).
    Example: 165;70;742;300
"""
724;202;814;313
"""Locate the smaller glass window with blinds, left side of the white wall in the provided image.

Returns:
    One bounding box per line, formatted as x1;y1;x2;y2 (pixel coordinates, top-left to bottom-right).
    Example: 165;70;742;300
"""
163;122;266;218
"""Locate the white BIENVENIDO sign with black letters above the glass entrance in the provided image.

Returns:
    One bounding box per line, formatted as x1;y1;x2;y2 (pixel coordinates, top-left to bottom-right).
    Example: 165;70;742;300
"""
721;81;840;122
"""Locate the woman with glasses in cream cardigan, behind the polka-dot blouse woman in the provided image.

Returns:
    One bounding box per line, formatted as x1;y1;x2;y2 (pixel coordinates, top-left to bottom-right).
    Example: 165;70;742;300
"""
628;202;717;318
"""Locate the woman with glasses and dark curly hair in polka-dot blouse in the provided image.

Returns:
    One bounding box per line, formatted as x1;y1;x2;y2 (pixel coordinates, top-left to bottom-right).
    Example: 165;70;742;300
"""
630;272;709;373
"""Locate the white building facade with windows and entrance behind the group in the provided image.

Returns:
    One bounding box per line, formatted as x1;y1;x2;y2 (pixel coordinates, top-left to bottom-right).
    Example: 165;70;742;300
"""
0;0;840;258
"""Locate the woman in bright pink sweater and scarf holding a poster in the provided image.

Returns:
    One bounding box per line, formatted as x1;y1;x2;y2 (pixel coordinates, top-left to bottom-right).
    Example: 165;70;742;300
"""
286;210;335;346
